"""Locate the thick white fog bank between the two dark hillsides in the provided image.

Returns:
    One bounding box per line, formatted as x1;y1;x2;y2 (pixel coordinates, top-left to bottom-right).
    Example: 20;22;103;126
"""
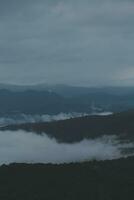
0;131;133;164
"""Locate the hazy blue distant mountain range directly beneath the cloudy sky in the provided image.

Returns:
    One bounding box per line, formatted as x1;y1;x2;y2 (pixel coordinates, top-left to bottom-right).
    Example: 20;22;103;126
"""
0;85;134;117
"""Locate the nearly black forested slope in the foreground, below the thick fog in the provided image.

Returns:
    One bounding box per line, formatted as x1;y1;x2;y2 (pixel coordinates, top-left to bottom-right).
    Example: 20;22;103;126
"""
0;157;134;200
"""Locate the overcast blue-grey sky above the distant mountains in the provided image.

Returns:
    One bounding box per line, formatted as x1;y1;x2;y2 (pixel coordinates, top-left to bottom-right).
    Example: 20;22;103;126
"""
0;0;134;86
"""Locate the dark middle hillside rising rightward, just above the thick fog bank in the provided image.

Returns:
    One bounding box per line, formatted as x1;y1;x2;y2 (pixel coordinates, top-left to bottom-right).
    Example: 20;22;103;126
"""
1;111;134;142
